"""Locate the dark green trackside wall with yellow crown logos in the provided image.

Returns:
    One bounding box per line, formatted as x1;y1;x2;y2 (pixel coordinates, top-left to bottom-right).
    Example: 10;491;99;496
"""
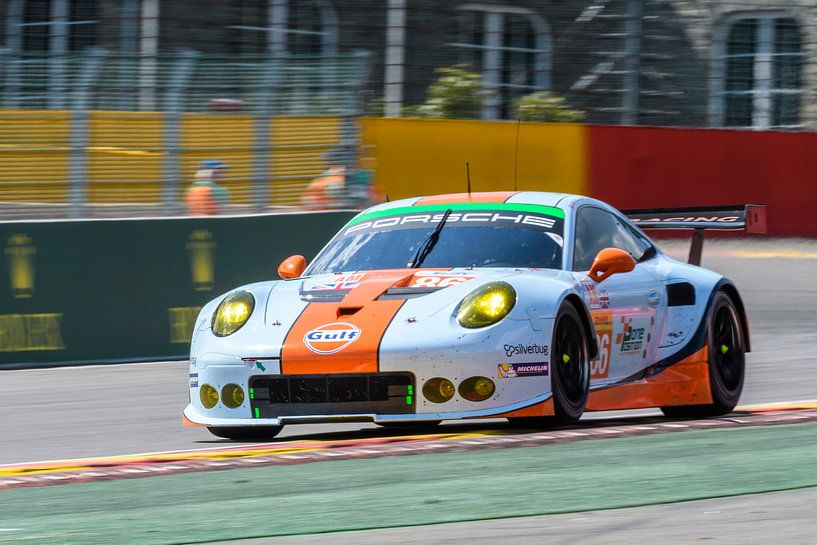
0;212;352;369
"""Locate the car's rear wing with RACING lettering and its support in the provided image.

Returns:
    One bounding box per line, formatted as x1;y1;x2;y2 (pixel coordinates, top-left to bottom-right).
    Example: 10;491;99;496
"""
621;204;766;265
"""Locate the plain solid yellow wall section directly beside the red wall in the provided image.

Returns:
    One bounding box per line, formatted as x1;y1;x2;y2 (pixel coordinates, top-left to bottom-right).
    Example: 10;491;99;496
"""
363;118;588;200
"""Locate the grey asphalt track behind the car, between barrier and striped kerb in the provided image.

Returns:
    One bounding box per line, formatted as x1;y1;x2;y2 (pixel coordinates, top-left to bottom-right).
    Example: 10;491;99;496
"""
0;236;817;464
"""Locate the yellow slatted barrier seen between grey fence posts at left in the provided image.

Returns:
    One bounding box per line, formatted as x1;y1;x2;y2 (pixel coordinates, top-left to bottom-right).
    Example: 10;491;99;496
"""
0;110;341;206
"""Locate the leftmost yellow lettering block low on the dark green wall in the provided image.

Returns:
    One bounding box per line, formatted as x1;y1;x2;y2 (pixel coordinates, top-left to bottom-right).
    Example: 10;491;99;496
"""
0;314;65;352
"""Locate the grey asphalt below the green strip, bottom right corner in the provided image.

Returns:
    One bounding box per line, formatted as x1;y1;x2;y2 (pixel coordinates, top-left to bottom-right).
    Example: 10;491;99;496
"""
219;488;817;545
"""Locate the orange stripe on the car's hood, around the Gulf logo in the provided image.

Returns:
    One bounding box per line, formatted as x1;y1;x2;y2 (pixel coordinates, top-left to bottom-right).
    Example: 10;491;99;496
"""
281;270;416;375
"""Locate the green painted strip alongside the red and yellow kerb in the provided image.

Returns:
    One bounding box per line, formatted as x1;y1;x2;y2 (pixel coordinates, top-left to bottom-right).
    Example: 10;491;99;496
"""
0;424;817;545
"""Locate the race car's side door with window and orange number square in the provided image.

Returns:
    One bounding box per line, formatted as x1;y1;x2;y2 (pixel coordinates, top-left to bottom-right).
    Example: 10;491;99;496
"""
572;205;665;386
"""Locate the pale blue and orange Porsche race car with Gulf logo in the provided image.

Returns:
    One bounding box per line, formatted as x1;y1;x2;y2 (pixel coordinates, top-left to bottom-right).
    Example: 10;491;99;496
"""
184;192;765;439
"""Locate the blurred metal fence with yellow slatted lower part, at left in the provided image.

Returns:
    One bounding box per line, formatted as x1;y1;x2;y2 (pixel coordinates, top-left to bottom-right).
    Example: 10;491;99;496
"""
0;48;369;219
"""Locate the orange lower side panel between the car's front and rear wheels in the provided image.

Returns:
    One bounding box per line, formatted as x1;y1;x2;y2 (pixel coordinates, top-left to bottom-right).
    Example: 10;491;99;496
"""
586;347;712;411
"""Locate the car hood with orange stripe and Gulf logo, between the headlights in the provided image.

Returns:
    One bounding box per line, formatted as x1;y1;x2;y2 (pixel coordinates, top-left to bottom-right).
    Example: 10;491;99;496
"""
256;268;560;374
